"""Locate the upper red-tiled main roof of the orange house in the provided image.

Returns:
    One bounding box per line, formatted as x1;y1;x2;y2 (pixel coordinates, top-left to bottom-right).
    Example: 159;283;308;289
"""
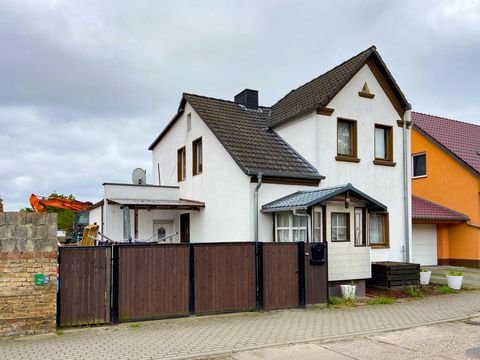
412;112;480;175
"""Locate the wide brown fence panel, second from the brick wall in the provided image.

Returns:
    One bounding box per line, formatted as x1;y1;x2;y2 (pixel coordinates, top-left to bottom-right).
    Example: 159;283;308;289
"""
114;244;190;321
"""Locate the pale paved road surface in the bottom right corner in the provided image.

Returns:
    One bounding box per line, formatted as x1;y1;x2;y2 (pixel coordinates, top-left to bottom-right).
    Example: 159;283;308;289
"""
215;317;480;360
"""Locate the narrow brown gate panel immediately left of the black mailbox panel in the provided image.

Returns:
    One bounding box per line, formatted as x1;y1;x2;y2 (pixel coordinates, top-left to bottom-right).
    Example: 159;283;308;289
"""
262;243;300;310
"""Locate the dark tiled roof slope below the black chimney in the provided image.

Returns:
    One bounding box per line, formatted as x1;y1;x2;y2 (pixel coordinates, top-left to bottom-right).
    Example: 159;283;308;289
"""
183;94;323;179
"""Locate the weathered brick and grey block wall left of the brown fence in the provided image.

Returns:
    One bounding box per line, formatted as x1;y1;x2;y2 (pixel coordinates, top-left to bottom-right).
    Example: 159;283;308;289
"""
0;212;57;336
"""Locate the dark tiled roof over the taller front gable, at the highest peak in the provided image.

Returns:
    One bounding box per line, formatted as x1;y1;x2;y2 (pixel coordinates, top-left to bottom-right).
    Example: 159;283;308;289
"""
270;46;410;126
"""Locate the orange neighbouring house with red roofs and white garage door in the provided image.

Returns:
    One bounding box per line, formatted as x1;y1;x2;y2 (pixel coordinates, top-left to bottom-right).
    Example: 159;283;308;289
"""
411;112;480;268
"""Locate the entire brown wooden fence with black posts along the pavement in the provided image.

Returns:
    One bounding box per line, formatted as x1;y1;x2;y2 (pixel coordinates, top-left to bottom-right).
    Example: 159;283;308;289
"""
58;242;327;326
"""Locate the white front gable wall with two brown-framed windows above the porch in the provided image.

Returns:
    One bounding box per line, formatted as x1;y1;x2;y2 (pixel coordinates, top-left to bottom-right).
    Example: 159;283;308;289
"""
275;65;410;261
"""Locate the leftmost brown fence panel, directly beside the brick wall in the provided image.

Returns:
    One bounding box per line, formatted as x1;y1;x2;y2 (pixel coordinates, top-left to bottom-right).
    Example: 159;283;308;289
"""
57;246;111;326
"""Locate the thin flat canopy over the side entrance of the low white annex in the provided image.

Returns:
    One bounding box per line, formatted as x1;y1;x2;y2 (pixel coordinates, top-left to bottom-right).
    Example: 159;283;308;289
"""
107;198;205;210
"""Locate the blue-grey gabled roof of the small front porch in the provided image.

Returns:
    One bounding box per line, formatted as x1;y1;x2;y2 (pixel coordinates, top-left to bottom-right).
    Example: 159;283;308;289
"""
262;183;387;212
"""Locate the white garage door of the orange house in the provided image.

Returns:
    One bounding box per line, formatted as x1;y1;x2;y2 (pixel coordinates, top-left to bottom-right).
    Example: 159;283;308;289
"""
412;224;437;265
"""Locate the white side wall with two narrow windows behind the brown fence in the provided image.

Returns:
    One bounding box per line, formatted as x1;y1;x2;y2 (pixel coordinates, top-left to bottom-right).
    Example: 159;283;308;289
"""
152;103;251;242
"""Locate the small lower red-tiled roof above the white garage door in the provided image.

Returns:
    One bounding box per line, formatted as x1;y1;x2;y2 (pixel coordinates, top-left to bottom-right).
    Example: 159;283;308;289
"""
412;195;469;222
